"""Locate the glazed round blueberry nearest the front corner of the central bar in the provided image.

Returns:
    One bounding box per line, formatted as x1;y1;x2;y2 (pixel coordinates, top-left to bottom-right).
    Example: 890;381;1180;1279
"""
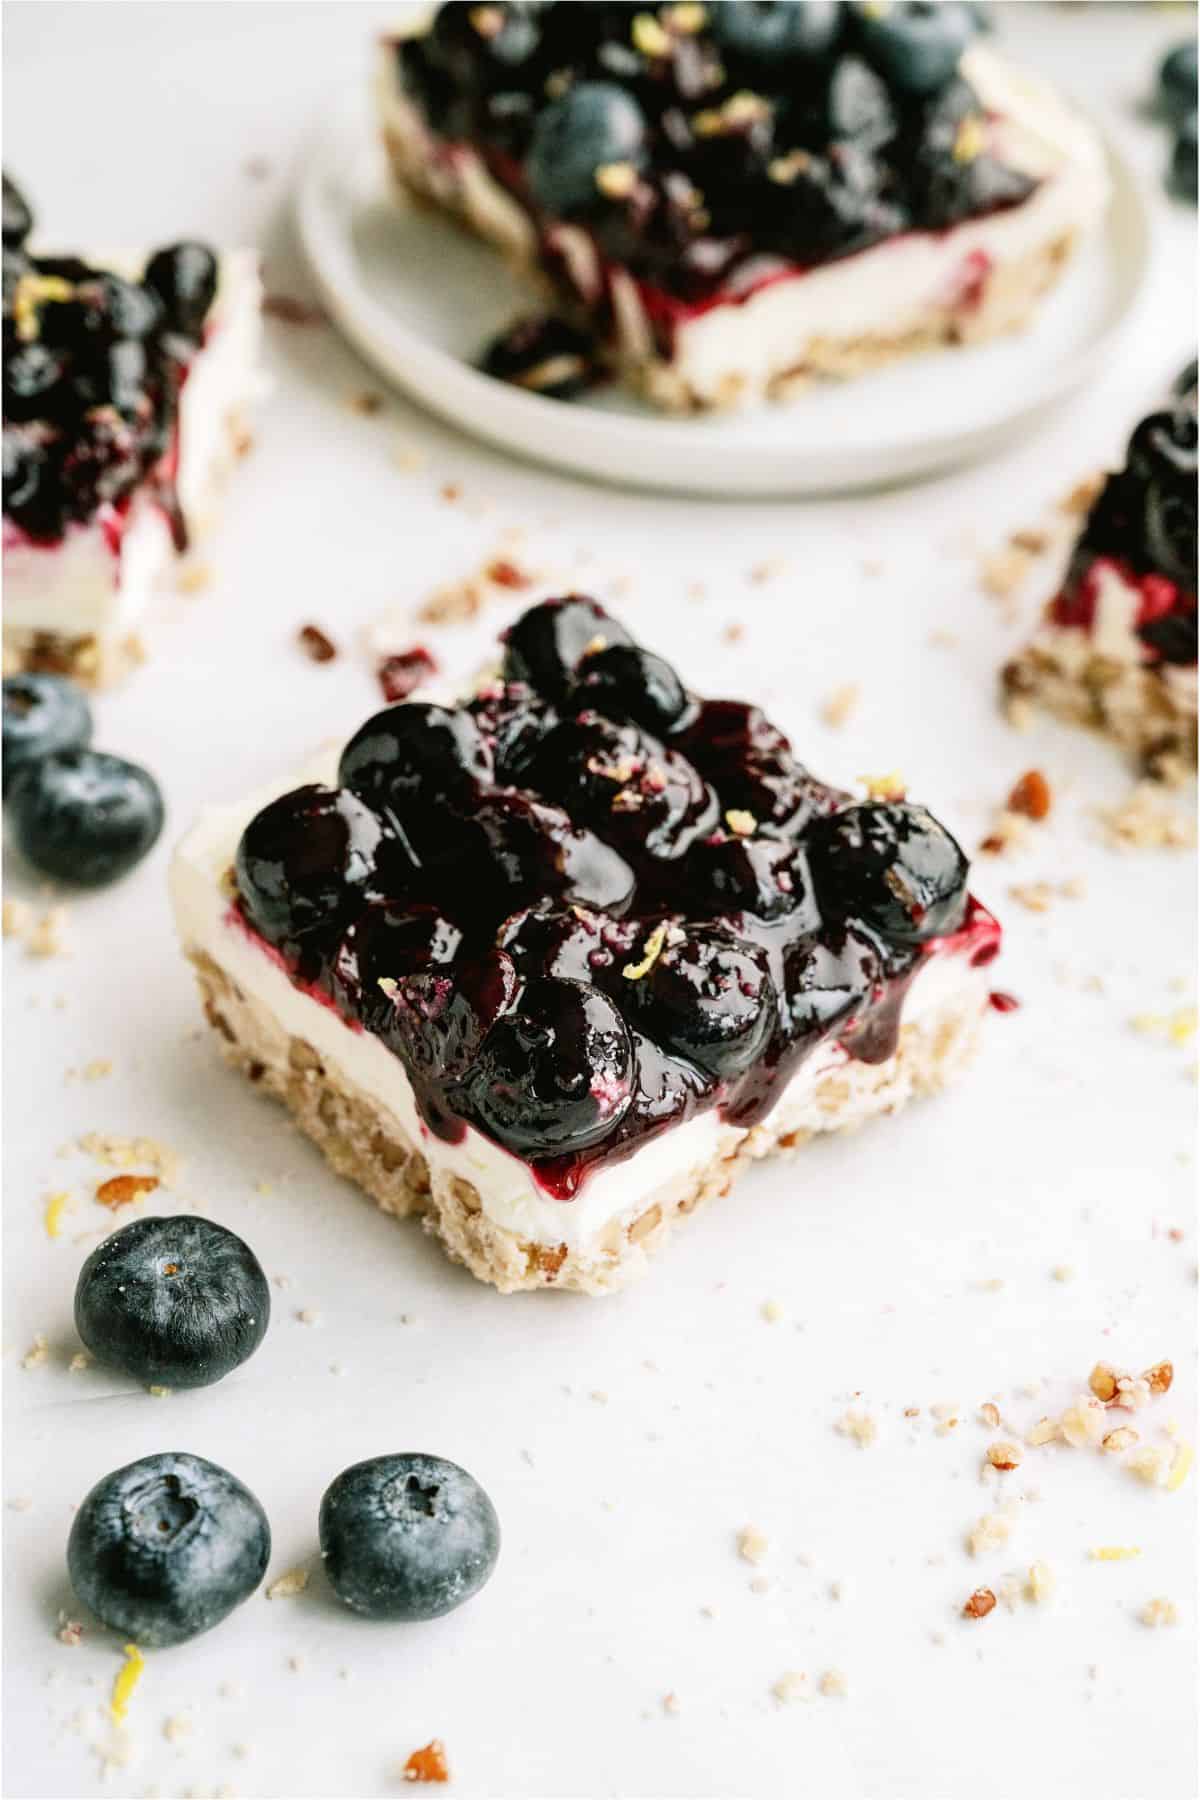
464;977;633;1157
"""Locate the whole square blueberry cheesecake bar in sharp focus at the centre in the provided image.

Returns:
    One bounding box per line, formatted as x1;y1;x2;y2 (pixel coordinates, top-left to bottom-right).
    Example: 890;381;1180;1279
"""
173;596;1000;1292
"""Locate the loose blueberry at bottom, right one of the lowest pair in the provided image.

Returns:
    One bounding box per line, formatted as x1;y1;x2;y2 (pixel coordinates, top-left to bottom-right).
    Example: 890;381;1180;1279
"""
318;1453;500;1620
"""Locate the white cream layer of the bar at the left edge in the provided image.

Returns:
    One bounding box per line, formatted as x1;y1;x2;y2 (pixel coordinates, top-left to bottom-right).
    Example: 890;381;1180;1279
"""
4;250;261;641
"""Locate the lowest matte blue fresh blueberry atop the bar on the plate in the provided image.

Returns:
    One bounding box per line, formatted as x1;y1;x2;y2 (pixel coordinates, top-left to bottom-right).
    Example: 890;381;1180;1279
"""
525;81;646;216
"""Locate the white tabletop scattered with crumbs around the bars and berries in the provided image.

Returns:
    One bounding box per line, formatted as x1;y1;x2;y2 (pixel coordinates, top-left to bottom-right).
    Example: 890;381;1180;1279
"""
4;4;1196;1800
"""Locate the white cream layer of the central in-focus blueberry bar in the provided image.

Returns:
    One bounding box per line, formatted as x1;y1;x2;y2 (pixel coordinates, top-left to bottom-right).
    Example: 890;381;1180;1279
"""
171;752;990;1251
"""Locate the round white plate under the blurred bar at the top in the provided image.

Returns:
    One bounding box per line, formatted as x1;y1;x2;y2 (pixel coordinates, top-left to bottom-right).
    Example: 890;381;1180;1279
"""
297;95;1151;497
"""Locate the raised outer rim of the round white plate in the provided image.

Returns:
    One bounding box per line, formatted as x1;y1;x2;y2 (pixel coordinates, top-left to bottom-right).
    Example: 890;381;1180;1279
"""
291;86;1159;500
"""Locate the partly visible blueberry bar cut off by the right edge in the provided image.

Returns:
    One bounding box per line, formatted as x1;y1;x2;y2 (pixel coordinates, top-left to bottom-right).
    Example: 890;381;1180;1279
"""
1004;365;1196;781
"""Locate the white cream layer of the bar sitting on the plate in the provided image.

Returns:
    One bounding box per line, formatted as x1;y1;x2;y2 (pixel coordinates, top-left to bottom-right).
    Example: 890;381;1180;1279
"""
378;45;1108;398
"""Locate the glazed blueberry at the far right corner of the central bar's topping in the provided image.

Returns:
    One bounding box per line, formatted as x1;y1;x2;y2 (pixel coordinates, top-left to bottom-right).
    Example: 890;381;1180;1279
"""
804;801;966;945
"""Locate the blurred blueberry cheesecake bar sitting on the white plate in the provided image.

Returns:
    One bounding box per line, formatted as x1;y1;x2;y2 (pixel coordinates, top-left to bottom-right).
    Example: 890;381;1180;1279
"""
378;0;1108;409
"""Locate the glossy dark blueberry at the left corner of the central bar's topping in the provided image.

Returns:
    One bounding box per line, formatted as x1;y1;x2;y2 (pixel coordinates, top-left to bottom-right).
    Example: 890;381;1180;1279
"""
234;784;408;949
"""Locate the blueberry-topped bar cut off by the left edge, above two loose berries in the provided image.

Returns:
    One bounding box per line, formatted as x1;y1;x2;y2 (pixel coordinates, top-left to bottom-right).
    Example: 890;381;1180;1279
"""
4;178;259;684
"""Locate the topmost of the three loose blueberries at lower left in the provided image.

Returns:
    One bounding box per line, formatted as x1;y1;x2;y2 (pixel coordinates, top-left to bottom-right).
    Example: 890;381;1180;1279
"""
76;1213;272;1388
